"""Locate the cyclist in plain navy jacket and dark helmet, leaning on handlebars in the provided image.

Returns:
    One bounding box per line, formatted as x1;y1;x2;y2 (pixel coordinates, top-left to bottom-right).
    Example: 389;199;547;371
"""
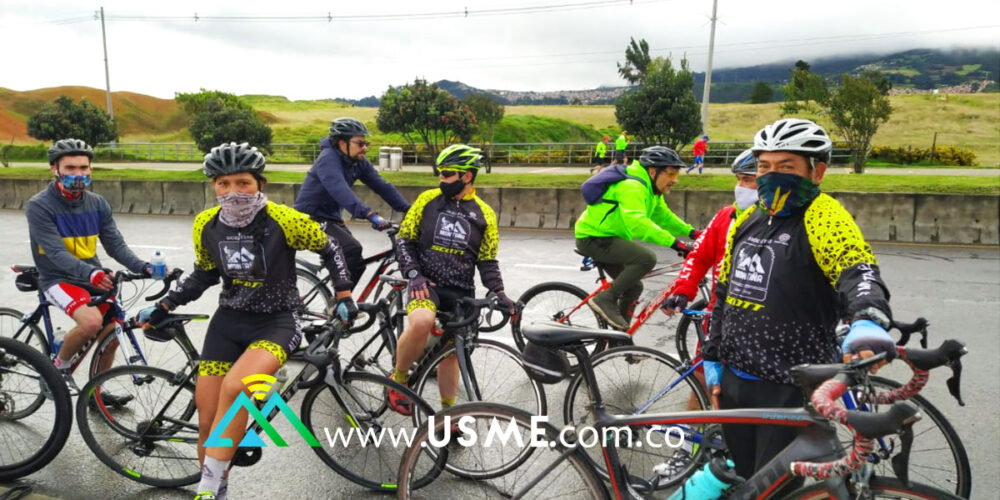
295;114;410;284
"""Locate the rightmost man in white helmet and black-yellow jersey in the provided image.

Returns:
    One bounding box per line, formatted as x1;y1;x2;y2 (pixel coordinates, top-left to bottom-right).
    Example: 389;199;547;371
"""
702;118;895;484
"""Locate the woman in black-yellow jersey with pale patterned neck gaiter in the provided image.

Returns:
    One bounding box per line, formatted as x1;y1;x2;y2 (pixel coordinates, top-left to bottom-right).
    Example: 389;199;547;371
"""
138;143;357;500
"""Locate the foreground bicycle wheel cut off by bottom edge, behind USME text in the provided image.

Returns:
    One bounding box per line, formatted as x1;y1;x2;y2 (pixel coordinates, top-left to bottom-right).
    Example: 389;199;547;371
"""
398;402;608;500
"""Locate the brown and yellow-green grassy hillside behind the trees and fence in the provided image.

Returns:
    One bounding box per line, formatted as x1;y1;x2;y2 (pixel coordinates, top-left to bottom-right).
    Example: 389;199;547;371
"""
0;87;1000;165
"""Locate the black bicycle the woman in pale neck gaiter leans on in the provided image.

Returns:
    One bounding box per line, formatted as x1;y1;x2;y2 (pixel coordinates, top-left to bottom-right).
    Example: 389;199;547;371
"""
76;319;432;491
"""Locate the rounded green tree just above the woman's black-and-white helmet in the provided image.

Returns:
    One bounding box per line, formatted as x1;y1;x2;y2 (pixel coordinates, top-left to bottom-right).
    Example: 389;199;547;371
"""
175;89;271;153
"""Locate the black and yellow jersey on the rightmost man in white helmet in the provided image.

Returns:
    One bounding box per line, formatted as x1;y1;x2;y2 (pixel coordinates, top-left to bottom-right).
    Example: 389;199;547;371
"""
702;194;891;384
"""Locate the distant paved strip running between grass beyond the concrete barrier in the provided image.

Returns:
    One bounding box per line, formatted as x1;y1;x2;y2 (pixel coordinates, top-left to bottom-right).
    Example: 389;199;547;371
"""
11;162;1000;177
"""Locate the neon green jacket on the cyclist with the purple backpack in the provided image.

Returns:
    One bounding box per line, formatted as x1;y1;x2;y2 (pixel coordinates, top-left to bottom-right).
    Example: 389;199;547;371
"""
574;161;693;246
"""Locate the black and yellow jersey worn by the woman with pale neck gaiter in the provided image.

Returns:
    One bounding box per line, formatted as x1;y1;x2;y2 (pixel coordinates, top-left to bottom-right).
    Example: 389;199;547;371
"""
167;201;351;313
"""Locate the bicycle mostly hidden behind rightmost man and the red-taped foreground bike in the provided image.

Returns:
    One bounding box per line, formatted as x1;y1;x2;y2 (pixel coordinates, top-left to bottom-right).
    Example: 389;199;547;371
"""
563;310;972;497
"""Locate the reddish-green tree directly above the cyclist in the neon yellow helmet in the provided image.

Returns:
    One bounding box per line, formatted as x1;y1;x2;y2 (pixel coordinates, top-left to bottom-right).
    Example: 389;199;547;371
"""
375;78;476;156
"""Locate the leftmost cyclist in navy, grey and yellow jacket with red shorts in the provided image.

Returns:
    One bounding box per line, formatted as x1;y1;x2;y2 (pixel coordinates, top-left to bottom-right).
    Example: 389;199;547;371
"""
25;139;150;392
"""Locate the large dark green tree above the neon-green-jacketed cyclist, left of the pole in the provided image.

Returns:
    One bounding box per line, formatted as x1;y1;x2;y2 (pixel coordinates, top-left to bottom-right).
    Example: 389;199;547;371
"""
615;55;701;149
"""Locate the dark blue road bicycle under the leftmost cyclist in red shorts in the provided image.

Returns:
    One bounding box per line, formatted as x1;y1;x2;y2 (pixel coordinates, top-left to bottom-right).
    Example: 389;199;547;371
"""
0;265;208;386
